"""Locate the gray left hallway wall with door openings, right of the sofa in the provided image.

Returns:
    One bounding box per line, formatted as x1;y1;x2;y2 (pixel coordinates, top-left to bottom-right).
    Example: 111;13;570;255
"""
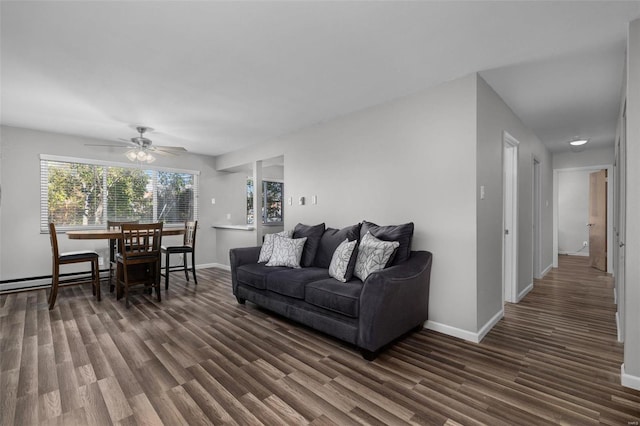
476;76;553;328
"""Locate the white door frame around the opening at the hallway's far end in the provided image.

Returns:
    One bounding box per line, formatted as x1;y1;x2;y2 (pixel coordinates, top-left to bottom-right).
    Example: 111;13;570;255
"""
553;164;613;271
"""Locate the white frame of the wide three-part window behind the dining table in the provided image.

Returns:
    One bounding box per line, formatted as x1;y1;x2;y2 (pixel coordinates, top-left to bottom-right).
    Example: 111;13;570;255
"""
39;154;200;234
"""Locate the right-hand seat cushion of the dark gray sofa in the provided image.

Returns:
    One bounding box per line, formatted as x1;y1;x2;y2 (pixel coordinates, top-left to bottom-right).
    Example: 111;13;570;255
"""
304;278;363;318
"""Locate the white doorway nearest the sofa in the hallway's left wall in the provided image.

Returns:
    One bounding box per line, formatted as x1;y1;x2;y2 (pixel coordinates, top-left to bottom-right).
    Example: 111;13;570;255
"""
502;132;519;303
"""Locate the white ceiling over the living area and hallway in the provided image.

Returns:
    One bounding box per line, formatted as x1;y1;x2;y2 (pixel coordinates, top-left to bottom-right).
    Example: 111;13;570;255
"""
0;1;640;155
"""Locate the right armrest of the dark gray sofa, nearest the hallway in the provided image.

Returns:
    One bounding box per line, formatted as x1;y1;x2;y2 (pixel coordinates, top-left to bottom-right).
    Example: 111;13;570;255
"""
358;251;432;352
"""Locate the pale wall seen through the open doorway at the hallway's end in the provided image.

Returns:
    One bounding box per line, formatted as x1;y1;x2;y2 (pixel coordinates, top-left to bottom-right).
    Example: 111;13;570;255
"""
557;170;593;256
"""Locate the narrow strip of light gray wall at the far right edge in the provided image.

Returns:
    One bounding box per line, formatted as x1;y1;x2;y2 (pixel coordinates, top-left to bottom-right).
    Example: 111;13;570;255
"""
623;20;640;389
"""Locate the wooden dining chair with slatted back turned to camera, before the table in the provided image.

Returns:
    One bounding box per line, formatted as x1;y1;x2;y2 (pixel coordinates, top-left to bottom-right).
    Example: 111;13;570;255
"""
116;223;162;308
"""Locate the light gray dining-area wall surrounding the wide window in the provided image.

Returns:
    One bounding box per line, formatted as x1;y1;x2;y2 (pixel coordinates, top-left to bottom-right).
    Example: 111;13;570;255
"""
0;126;218;286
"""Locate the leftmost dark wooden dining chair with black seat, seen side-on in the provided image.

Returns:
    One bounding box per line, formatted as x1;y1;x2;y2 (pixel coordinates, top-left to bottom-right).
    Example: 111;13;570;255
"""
49;222;101;310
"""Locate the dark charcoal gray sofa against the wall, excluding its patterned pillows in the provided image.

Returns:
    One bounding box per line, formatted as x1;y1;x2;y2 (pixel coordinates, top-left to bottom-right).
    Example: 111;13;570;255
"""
230;221;432;360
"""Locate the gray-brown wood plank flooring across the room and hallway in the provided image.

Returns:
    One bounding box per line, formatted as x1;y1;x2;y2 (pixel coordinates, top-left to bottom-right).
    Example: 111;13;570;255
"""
0;256;640;426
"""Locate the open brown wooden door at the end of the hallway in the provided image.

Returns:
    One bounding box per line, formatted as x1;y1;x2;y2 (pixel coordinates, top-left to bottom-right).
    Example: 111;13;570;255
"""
589;170;607;272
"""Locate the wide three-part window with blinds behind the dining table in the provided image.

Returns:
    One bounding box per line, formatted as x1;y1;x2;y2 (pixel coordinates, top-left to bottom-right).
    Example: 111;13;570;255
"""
40;155;199;232
